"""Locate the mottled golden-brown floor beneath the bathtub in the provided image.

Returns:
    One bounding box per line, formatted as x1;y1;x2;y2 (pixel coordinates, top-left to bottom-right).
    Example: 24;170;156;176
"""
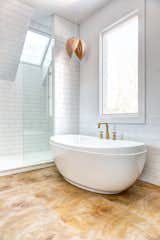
0;166;160;240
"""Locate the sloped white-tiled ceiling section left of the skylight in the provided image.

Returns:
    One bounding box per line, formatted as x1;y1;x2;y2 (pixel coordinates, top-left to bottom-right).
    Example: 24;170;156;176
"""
0;0;32;81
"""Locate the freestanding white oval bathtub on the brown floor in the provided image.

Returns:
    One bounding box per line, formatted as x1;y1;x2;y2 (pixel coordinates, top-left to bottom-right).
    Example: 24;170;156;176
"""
50;135;147;194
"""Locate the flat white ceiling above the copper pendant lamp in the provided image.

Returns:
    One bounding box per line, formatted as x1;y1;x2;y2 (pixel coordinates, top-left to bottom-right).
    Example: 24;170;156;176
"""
21;0;109;23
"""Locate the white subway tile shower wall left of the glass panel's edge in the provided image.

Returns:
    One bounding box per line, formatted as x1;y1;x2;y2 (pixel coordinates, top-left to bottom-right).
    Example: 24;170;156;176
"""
0;76;23;156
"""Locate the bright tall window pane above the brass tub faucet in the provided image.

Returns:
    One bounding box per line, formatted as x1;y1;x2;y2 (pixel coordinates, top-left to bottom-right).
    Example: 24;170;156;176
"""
103;16;138;114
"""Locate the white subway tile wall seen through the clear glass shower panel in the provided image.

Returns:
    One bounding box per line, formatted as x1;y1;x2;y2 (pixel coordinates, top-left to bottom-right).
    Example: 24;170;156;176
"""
21;64;51;153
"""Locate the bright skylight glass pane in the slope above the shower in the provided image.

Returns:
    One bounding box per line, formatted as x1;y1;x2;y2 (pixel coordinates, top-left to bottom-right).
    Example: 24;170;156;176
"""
21;31;49;65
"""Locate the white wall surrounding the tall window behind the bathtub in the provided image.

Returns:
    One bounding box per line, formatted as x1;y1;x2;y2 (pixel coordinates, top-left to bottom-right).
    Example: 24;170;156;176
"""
80;0;160;185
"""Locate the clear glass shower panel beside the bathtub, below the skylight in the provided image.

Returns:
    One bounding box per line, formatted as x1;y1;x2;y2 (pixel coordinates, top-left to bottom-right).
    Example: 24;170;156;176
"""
21;33;54;165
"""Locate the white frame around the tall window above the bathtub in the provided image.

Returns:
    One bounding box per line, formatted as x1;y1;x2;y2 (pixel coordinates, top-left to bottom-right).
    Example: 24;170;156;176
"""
99;10;145;124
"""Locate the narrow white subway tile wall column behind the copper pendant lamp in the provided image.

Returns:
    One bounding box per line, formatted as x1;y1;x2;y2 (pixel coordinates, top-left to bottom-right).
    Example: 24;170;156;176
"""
54;16;80;134
